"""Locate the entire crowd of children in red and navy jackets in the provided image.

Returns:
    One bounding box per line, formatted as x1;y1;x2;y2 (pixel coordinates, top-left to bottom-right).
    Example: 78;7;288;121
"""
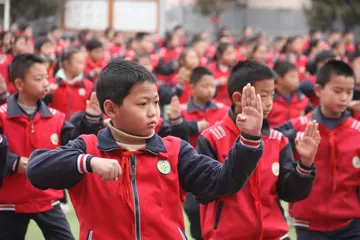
0;21;360;240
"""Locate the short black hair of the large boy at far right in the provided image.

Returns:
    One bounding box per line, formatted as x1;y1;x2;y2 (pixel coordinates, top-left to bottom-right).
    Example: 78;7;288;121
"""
316;60;355;87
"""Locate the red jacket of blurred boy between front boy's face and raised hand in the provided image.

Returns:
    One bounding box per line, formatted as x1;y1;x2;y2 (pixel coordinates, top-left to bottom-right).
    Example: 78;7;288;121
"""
180;99;229;148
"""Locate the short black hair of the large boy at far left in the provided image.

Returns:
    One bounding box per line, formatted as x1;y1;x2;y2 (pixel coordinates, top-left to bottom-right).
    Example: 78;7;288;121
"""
9;53;44;82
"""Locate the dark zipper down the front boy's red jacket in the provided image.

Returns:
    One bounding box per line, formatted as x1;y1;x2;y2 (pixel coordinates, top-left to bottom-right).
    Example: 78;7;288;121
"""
130;155;141;240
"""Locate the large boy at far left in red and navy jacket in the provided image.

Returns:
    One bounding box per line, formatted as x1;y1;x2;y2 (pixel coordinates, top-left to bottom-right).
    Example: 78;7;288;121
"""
0;54;101;240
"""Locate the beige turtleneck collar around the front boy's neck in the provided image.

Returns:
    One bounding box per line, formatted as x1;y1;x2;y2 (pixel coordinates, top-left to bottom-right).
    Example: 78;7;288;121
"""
108;122;154;151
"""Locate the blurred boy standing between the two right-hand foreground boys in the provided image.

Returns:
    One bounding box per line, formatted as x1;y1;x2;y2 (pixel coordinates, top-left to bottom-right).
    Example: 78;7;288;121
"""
267;61;311;127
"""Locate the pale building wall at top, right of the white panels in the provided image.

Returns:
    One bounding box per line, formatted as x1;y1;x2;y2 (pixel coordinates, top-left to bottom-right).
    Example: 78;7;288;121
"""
165;0;309;37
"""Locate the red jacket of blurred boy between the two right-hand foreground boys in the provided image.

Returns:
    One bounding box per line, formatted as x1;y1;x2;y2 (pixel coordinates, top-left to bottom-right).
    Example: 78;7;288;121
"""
267;91;311;127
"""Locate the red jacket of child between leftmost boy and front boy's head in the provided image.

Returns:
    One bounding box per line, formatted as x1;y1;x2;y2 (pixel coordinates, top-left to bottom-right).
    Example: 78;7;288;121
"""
49;78;93;120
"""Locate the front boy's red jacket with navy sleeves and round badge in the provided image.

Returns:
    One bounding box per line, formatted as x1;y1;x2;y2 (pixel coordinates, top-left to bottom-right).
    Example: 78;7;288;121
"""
27;128;263;240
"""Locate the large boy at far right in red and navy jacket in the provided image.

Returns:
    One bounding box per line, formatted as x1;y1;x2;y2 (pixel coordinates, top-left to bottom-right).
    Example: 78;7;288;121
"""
279;60;360;240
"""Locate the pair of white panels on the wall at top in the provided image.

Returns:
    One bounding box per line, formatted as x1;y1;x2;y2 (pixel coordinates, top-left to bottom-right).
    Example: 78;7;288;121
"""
62;0;161;33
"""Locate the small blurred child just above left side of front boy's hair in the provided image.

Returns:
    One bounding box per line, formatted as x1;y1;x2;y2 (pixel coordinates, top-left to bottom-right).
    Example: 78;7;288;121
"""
84;39;107;83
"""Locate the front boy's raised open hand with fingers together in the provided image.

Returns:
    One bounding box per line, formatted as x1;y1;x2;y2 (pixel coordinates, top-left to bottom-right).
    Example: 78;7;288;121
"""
236;84;263;136
